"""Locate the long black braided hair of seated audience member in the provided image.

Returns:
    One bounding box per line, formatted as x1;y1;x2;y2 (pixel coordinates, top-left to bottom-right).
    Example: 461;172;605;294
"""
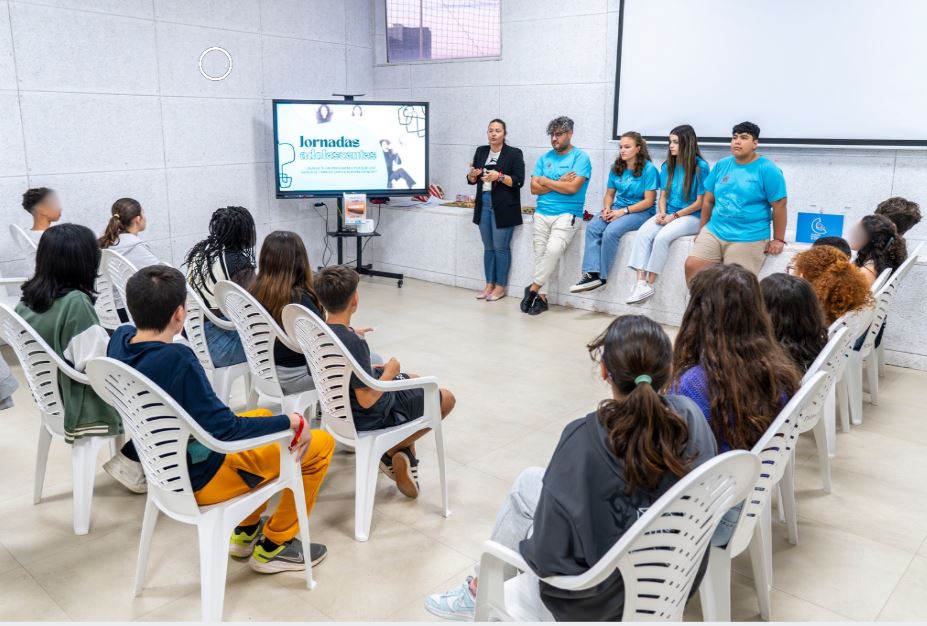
184;206;257;290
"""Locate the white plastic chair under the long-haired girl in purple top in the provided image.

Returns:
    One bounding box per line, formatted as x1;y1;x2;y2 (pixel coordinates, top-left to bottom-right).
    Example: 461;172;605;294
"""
699;372;827;622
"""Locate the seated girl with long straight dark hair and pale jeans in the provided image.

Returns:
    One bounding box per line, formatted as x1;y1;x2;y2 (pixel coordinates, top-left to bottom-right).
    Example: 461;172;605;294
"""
625;124;710;304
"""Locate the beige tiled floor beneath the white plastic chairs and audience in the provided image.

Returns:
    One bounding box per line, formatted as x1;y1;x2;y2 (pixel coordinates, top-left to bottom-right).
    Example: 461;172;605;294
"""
0;280;927;621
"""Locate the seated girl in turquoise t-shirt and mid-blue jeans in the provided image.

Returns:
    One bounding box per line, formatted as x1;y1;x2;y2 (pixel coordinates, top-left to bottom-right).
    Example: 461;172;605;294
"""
570;132;660;293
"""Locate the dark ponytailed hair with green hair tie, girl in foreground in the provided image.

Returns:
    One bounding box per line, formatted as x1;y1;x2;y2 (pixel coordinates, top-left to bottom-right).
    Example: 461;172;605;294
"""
588;315;692;494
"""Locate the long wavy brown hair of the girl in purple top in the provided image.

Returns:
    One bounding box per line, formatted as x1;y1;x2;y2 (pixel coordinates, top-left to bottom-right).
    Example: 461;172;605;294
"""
673;264;800;450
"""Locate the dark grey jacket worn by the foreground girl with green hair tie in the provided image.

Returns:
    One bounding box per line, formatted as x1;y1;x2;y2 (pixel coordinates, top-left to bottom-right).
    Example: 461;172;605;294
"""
519;396;718;622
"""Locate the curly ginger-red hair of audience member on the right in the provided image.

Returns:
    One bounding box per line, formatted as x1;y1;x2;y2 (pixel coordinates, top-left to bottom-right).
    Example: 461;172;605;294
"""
792;246;872;326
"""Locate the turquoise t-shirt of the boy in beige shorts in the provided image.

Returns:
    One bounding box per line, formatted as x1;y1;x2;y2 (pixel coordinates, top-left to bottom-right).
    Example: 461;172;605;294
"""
705;156;786;241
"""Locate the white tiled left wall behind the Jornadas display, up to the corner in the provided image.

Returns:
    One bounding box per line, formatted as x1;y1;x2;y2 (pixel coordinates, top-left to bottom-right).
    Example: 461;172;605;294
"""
0;0;373;275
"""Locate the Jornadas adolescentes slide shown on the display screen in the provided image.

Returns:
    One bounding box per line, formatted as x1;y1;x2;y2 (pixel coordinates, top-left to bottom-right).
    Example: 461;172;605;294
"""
274;100;428;197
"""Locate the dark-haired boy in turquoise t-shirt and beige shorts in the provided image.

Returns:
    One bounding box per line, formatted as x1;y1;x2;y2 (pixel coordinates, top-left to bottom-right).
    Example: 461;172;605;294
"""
686;122;787;283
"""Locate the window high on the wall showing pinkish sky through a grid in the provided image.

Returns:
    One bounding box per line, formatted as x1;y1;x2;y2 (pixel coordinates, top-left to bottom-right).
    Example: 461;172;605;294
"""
386;0;502;63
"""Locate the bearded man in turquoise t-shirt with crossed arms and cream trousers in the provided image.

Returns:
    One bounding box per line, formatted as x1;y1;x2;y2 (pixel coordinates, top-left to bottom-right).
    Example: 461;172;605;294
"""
521;116;592;315
